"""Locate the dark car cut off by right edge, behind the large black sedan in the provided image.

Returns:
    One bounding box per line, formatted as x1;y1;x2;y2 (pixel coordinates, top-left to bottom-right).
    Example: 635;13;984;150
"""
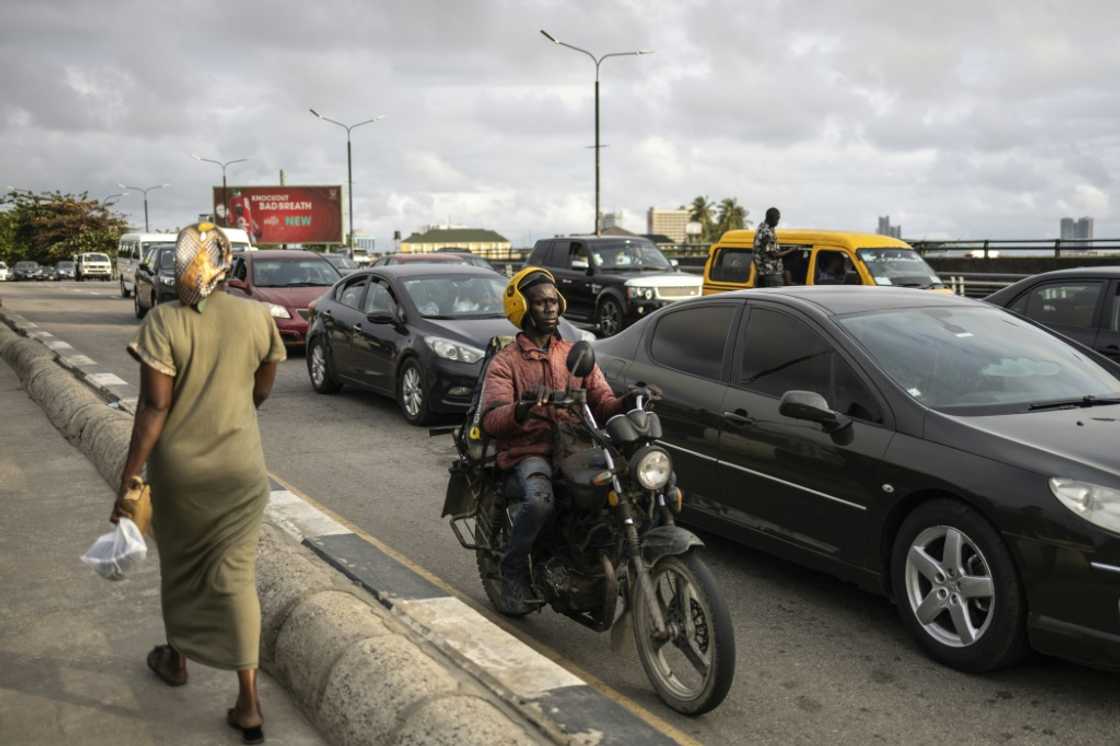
984;267;1120;362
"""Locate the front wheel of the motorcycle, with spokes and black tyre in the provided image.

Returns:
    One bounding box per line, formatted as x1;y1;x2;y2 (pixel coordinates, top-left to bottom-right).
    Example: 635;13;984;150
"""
632;551;735;716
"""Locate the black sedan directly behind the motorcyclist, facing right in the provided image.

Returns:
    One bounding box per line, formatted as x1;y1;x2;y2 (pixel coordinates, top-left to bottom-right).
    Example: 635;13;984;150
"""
307;263;594;425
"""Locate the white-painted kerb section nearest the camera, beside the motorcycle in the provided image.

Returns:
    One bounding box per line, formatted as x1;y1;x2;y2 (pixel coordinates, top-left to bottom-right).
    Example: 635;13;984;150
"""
394;596;585;699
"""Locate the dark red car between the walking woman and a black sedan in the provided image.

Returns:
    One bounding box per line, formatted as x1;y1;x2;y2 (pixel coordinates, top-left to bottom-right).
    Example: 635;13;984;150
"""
226;251;342;347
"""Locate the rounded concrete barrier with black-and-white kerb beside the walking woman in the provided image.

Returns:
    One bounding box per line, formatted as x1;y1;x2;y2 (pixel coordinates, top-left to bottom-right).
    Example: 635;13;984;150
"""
0;309;690;746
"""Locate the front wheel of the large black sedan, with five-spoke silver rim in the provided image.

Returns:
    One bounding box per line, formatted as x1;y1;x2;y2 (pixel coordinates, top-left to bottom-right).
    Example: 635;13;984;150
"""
890;500;1027;673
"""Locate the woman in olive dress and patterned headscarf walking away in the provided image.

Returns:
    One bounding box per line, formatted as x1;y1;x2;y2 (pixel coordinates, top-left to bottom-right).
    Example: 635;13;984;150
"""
111;223;284;744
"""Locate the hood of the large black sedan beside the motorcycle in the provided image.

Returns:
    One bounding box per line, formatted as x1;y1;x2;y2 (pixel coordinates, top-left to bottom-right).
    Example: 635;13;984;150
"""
926;404;1120;479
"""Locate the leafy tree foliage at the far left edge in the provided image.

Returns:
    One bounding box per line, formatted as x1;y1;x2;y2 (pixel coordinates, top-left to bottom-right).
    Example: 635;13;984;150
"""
0;189;128;264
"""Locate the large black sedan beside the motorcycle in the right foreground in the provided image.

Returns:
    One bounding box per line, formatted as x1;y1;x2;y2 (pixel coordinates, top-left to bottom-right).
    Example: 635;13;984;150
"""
596;283;1120;671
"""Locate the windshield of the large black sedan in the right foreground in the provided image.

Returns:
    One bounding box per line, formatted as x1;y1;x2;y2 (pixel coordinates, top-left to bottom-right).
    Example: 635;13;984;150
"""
838;307;1120;416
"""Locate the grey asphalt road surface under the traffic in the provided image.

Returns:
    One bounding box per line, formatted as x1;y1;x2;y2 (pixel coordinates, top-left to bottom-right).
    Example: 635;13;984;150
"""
0;282;1120;745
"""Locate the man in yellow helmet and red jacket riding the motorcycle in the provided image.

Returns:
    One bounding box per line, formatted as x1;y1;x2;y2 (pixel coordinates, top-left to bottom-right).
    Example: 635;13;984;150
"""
482;267;634;605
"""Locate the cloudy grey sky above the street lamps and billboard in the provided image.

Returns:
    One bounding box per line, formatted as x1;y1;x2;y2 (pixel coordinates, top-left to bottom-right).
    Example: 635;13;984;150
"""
0;0;1120;246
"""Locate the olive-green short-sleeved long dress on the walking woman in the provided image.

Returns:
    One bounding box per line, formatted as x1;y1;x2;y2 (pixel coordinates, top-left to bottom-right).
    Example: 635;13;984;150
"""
129;291;284;670
